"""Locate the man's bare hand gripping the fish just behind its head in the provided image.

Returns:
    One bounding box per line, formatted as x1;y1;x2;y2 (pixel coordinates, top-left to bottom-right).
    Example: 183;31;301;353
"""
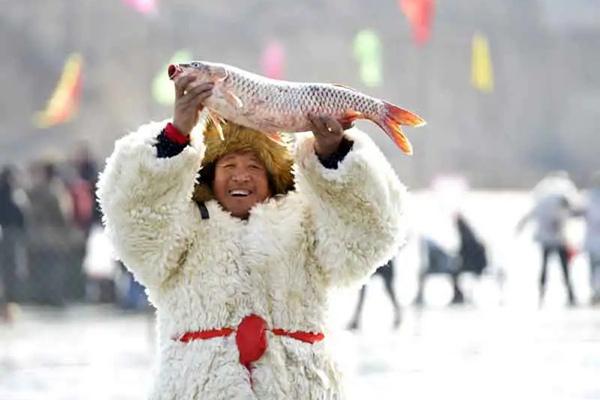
173;73;214;135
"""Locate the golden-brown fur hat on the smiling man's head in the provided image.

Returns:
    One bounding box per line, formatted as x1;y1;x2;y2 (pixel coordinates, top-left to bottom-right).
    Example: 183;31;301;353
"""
193;121;294;202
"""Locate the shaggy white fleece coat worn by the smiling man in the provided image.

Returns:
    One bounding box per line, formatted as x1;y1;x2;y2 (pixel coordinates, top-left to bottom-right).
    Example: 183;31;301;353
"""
98;122;405;400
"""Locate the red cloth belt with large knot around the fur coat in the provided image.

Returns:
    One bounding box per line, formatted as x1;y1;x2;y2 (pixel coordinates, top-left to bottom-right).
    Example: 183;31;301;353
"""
175;314;325;369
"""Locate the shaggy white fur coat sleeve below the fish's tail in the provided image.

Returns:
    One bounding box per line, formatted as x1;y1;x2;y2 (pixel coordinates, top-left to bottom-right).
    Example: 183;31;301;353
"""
296;129;406;286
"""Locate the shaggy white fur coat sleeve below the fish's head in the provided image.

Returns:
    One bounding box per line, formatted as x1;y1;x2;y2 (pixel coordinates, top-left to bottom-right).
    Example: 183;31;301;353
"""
97;122;204;288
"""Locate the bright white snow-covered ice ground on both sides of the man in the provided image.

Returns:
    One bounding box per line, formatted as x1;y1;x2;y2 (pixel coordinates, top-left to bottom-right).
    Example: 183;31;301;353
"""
0;192;600;400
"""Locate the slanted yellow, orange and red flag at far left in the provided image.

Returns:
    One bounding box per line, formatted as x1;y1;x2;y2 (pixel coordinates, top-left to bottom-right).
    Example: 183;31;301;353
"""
34;53;83;128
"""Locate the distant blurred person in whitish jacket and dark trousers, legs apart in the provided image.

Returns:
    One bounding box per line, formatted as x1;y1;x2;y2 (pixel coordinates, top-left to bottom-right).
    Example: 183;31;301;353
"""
517;171;577;306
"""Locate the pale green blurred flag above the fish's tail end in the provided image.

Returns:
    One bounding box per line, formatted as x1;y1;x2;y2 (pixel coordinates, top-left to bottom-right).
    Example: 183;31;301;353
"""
353;29;383;87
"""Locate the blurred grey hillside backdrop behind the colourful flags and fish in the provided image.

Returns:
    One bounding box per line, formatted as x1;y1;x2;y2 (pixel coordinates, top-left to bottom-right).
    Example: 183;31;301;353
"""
0;0;600;187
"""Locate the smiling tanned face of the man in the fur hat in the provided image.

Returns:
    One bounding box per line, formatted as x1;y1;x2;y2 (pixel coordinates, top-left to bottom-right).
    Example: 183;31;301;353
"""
212;151;271;218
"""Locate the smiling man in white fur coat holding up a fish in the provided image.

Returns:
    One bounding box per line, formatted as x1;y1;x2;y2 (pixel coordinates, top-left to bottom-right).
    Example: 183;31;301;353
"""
98;73;406;400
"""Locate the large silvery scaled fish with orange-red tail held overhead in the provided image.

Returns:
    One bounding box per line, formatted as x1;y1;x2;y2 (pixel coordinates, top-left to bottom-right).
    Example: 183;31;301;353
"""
167;61;426;155
